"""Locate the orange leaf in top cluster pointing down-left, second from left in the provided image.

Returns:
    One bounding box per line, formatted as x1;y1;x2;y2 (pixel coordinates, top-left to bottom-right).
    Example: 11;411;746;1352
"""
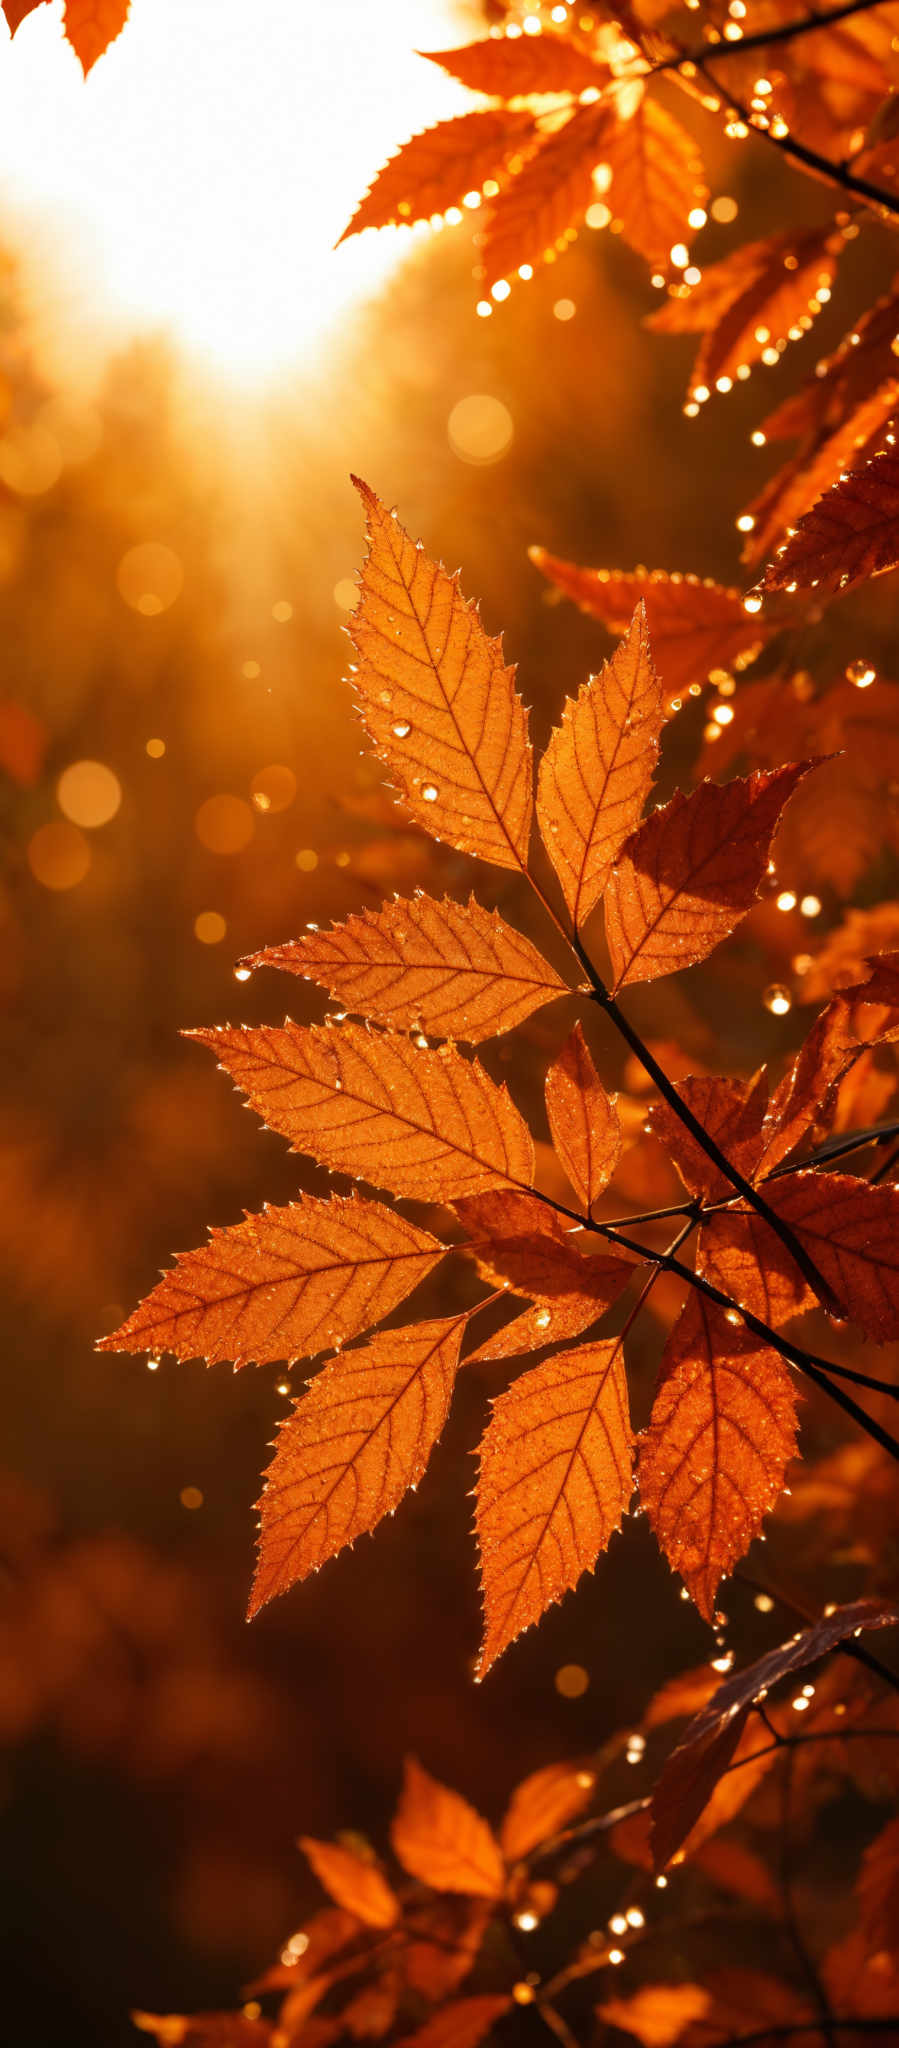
483;102;614;285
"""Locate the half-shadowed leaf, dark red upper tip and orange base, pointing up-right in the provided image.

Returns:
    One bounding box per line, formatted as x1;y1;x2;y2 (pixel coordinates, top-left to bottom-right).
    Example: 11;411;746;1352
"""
606;762;813;989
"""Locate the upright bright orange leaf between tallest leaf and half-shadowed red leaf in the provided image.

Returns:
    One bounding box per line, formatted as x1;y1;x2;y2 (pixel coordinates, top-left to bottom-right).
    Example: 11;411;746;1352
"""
537;604;663;926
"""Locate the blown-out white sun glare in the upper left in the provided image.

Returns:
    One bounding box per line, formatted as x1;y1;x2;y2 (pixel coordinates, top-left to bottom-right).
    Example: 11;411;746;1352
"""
0;0;467;380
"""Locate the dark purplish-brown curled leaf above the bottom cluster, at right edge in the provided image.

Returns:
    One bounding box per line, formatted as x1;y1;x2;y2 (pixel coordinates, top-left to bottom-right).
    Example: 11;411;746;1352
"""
653;1599;899;1868
